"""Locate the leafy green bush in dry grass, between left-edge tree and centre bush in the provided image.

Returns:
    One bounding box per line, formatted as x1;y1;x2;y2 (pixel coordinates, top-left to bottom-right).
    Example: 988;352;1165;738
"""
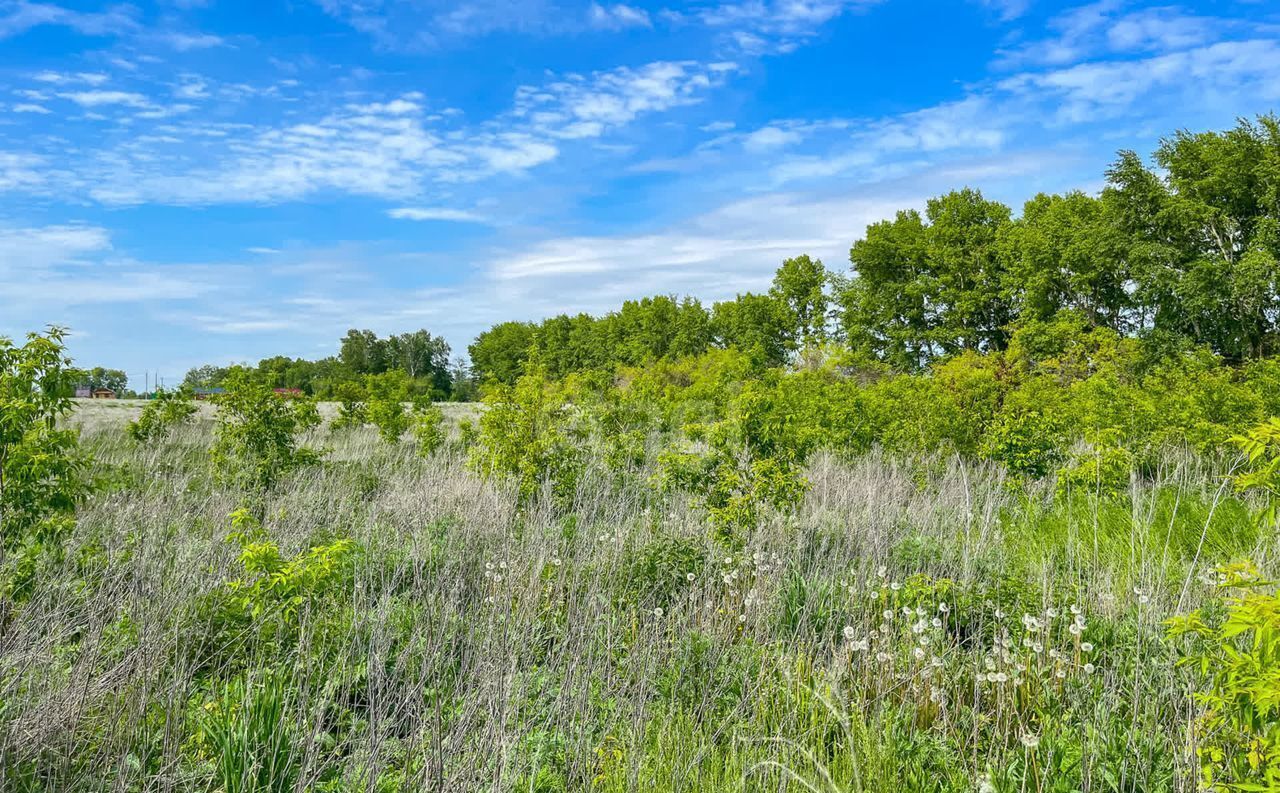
209;370;320;491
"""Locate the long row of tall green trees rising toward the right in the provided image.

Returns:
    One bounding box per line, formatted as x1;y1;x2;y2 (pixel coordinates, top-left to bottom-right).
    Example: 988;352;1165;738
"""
177;115;1280;399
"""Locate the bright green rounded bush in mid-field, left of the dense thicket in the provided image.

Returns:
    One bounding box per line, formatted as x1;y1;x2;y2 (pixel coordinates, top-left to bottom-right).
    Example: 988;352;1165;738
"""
470;375;582;501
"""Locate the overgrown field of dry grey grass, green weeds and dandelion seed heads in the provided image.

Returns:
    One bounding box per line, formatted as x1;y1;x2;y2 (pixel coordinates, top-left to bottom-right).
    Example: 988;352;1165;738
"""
0;358;1280;792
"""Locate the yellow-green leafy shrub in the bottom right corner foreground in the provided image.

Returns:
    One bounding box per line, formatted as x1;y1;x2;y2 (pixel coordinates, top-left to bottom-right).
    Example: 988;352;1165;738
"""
1169;564;1280;790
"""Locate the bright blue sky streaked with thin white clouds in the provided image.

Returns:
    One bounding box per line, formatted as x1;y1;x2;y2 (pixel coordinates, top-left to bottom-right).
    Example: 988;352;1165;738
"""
0;0;1280;384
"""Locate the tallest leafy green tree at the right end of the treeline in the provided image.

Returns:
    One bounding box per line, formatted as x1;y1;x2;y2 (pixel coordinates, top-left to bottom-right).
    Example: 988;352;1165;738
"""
1103;116;1280;359
